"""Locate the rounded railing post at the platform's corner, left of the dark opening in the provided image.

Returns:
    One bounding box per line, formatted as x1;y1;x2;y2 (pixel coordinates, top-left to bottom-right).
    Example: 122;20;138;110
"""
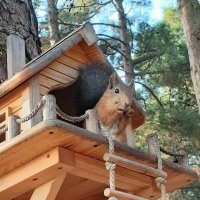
43;94;57;120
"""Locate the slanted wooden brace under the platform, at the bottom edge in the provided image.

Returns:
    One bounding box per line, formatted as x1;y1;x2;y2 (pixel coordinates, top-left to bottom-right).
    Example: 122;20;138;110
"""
30;173;66;200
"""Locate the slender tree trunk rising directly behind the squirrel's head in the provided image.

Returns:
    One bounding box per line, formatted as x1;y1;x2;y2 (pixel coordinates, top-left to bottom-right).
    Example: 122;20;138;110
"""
114;0;135;91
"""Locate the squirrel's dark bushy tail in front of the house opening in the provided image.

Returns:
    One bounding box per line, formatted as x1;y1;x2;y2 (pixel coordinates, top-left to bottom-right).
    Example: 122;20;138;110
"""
76;62;114;115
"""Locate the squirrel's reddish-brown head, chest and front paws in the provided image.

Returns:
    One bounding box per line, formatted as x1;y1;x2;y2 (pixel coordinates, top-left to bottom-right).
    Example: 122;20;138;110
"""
95;72;134;142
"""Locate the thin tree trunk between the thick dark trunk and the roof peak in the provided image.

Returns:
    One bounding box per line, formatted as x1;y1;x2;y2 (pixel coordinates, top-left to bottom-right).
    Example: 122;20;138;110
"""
47;0;61;46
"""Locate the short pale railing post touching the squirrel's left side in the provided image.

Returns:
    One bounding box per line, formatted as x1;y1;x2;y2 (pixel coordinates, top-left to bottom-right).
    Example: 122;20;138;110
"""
85;109;99;134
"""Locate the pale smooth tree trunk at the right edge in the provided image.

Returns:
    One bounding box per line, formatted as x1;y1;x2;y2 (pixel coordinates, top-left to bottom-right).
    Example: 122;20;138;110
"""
178;0;200;114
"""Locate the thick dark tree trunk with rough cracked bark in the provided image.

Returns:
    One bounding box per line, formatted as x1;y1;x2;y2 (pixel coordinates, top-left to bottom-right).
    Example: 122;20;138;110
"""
0;0;41;61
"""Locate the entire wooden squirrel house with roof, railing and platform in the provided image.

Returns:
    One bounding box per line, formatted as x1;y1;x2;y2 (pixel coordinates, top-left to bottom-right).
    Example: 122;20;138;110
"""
0;24;197;200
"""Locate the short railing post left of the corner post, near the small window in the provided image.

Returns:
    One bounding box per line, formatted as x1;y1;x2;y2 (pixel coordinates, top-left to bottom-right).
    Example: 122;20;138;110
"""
6;115;20;141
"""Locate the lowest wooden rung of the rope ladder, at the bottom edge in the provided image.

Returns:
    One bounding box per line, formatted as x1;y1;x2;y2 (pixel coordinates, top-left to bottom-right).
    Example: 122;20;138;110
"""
104;188;147;200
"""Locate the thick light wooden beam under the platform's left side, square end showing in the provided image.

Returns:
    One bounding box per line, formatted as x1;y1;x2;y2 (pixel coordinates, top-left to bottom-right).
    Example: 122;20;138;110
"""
0;147;75;200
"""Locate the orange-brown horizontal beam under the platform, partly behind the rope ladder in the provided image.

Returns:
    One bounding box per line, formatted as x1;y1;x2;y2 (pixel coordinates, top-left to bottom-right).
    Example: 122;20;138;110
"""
69;153;154;191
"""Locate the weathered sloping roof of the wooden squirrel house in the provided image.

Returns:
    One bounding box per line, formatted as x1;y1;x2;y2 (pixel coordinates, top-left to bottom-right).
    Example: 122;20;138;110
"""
0;23;145;128
